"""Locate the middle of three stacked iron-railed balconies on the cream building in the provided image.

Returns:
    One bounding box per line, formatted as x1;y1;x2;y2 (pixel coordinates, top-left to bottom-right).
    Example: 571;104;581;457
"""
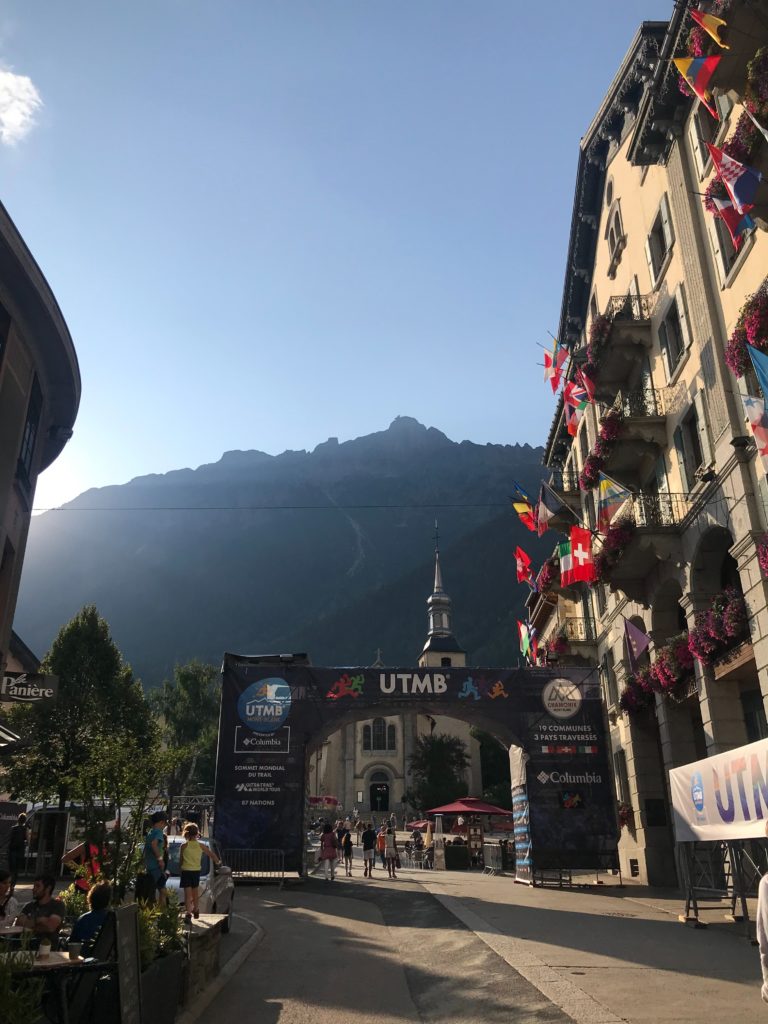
603;388;672;487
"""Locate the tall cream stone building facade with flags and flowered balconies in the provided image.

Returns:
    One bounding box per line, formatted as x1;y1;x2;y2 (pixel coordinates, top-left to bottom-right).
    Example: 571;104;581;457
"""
528;0;768;884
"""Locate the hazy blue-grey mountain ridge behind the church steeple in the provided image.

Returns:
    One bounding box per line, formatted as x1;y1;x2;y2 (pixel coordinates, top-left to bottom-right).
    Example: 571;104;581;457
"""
14;417;550;686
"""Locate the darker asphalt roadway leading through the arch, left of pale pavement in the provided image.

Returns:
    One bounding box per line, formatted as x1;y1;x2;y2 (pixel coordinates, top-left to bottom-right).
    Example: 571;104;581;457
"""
208;864;571;1024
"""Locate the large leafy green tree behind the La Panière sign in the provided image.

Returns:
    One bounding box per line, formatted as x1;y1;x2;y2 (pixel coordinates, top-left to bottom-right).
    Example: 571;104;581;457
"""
2;605;158;808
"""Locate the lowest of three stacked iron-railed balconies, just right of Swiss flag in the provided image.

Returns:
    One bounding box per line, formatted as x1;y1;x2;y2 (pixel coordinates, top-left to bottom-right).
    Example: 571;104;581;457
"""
604;494;690;604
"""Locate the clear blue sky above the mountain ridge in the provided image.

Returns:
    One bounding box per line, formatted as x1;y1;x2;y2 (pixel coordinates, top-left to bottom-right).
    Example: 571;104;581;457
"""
0;0;673;508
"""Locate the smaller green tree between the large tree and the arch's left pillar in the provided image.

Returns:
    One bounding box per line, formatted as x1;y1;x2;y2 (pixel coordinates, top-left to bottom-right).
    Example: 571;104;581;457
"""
153;660;220;801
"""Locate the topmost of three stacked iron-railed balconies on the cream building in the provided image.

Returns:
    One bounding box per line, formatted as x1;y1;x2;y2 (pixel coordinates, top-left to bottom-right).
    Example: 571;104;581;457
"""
589;295;655;401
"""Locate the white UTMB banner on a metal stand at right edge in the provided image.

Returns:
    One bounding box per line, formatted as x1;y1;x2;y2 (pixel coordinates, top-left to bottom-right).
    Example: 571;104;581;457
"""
670;739;768;843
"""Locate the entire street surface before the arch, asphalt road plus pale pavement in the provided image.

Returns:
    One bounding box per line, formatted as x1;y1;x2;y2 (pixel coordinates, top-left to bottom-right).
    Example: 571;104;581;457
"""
201;862;768;1024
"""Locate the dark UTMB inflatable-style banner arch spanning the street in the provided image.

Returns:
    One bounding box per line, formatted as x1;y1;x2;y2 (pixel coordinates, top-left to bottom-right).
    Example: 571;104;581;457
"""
214;654;617;871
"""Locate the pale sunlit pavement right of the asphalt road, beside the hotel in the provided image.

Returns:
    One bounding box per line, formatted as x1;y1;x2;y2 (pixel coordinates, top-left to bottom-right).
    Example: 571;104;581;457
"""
415;871;768;1024
